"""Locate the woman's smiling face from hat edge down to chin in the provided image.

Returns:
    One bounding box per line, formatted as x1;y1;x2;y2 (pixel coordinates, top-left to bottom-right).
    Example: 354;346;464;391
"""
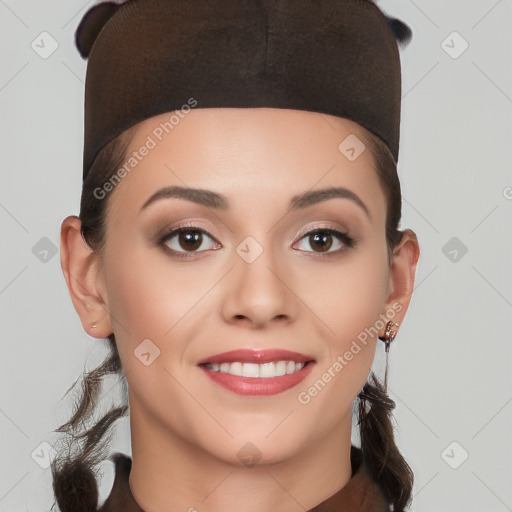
89;108;408;463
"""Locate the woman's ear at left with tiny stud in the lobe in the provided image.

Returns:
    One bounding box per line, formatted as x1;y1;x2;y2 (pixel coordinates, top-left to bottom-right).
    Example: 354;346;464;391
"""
60;215;113;338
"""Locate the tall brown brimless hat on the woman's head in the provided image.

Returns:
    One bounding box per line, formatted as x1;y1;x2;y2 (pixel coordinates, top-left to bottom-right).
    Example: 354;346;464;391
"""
75;0;412;179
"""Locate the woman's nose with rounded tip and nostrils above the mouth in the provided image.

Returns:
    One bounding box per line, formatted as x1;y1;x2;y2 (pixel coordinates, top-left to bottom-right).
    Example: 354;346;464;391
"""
222;242;299;329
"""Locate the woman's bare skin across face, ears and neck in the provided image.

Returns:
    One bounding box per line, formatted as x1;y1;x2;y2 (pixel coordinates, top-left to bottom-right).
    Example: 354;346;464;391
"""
61;108;419;512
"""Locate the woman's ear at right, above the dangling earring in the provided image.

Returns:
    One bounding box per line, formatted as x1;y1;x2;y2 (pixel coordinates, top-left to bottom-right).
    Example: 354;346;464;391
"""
379;229;420;336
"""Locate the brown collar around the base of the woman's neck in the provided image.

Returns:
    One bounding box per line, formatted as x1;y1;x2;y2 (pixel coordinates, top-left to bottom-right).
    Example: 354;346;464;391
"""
98;445;389;512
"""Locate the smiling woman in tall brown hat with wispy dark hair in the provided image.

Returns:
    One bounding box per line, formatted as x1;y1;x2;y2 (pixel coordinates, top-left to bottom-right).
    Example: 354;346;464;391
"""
52;0;419;512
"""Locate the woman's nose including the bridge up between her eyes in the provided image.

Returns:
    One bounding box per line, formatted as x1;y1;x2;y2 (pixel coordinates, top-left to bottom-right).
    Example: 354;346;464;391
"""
223;233;296;326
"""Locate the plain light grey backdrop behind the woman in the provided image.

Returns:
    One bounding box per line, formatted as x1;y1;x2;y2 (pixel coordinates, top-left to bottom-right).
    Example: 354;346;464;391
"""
0;0;512;512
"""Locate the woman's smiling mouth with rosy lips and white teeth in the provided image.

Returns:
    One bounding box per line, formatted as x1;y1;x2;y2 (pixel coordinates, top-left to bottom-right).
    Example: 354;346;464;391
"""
197;349;315;395
